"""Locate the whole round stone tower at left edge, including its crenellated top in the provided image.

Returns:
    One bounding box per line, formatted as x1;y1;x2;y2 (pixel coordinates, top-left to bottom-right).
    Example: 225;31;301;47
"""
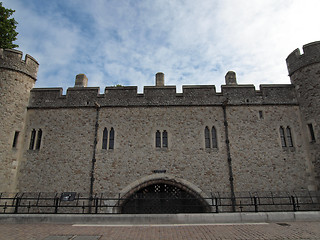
0;49;39;192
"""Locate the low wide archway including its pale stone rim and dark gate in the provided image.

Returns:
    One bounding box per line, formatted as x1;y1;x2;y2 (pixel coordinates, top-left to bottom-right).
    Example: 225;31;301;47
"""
118;177;210;214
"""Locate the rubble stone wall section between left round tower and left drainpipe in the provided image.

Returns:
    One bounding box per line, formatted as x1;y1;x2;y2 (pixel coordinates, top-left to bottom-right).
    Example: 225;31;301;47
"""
18;108;95;192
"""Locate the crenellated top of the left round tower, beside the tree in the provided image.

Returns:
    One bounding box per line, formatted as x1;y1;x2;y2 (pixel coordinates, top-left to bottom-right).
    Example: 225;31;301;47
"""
0;49;39;80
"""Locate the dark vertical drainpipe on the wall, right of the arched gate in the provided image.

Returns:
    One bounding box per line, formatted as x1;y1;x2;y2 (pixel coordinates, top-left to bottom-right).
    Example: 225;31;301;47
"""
222;99;236;212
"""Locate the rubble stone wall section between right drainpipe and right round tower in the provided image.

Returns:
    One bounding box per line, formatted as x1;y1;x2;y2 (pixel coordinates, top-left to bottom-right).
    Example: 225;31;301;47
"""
227;106;315;191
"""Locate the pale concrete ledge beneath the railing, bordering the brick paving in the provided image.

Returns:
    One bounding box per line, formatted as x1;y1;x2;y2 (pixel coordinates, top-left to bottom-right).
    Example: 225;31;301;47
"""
0;211;320;225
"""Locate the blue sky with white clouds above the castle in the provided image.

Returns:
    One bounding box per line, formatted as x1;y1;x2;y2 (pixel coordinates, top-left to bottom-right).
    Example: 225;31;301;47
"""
2;0;320;93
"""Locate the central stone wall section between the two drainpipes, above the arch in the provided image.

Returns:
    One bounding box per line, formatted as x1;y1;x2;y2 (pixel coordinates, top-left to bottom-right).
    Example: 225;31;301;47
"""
95;107;229;195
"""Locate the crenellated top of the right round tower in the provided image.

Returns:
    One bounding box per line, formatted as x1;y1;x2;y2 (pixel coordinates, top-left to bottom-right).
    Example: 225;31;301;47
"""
286;41;320;76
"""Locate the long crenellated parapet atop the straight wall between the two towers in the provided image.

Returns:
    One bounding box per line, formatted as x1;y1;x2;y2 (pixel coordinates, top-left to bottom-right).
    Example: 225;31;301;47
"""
28;84;298;108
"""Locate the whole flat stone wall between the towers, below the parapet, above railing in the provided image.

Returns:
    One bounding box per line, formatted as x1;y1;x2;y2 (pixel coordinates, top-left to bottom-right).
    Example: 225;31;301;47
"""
19;102;314;197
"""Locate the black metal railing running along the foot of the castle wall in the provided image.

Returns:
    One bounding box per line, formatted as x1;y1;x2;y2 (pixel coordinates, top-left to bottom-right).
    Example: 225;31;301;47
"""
0;191;320;214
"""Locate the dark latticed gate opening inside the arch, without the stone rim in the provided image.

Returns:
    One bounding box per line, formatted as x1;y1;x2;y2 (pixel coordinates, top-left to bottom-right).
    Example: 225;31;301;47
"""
121;183;207;214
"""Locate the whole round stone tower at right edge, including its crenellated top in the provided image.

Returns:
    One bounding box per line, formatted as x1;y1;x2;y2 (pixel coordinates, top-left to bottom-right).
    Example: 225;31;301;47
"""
286;41;320;190
